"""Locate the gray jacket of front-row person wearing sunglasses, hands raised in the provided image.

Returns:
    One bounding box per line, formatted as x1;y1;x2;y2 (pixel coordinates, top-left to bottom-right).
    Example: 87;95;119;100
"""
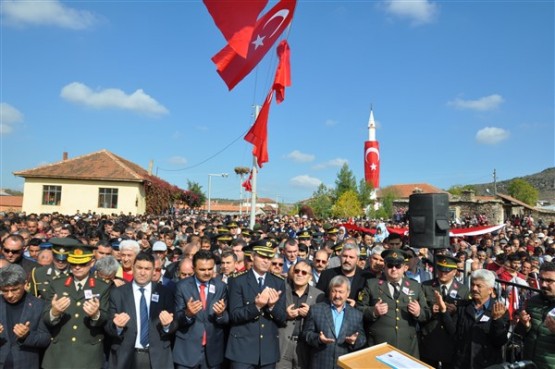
279;283;325;368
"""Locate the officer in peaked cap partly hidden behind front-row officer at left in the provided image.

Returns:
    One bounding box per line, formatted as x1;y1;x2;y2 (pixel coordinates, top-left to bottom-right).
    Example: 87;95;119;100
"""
29;238;73;297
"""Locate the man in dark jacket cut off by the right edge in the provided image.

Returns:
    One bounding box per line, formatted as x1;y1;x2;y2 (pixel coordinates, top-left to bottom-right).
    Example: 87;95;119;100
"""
515;262;555;369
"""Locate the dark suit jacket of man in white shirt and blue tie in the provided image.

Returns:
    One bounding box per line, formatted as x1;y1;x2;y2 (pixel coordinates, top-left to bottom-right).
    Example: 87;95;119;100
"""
106;283;177;369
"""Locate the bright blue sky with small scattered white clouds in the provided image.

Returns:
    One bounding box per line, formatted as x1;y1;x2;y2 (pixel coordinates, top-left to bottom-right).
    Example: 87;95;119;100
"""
0;0;555;202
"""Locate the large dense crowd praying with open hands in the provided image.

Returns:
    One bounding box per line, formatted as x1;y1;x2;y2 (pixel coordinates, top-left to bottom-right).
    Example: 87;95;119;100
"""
0;213;555;369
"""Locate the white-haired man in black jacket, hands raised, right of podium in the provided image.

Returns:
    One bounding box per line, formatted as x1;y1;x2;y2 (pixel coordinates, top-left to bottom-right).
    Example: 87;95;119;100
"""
434;269;509;369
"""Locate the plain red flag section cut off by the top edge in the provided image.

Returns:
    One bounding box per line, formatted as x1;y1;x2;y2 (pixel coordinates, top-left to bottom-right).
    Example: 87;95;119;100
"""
203;0;268;58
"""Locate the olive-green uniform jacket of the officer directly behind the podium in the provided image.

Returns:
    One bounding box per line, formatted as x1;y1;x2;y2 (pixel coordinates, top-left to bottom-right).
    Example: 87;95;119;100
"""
358;277;431;358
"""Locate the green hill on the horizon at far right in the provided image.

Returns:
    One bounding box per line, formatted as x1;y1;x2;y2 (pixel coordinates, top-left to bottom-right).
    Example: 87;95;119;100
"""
472;167;555;203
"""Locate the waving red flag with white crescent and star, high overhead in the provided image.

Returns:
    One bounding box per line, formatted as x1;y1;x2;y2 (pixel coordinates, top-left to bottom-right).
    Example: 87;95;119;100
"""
212;0;297;90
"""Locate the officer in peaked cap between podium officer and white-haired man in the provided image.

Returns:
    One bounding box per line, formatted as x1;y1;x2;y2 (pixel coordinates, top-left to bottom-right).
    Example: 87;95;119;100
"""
420;255;469;369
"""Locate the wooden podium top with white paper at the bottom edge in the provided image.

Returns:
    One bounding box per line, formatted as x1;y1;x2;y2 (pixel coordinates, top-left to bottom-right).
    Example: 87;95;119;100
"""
337;343;434;369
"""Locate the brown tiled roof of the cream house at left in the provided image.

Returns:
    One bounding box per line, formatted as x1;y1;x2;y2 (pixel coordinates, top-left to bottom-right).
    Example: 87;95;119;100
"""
14;149;148;182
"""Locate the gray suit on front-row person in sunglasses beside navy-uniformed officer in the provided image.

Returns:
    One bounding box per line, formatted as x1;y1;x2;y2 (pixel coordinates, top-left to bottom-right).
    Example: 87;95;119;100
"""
277;283;325;369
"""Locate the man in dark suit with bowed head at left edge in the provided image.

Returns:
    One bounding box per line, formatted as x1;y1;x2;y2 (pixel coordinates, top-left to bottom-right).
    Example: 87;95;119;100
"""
0;264;50;368
